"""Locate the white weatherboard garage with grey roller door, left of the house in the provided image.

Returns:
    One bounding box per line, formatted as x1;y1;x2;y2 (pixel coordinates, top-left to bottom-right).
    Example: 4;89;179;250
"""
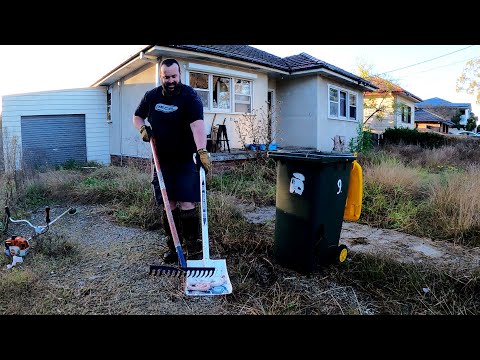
1;88;110;170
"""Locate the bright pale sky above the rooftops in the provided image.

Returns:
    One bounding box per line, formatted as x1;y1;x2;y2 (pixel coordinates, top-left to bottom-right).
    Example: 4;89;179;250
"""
0;45;480;116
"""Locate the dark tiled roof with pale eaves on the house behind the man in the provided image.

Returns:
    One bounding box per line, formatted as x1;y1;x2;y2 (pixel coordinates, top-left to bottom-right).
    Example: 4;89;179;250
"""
92;45;377;90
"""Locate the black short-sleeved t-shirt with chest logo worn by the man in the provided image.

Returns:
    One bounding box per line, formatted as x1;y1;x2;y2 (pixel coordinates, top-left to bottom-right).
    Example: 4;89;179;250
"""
135;84;203;162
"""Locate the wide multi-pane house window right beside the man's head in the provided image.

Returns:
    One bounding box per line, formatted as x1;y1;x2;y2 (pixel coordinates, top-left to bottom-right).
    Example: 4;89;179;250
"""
188;72;252;113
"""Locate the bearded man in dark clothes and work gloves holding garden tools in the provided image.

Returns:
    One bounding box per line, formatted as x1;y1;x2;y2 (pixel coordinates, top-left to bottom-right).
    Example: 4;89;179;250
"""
133;59;211;263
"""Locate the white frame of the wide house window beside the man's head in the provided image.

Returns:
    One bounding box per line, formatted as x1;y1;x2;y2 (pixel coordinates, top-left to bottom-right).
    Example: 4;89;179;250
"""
185;70;254;114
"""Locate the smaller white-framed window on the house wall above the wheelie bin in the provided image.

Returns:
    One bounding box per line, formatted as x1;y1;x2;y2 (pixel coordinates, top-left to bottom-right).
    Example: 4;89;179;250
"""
328;85;357;120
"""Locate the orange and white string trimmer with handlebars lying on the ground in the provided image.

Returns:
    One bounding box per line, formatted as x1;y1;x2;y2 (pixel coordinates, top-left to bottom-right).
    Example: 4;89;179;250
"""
4;206;77;269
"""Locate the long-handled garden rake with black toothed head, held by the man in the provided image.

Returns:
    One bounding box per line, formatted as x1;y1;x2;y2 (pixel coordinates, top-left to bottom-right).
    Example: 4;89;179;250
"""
149;137;215;278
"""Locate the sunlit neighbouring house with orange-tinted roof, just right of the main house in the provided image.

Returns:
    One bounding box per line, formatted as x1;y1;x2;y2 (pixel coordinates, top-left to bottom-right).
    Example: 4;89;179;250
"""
363;77;422;136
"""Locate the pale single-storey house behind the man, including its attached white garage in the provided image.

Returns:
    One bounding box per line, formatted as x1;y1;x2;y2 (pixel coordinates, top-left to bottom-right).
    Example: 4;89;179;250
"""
3;45;377;166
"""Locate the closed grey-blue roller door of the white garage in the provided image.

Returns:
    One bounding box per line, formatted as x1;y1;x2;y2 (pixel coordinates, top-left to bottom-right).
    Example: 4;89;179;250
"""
21;114;87;168
